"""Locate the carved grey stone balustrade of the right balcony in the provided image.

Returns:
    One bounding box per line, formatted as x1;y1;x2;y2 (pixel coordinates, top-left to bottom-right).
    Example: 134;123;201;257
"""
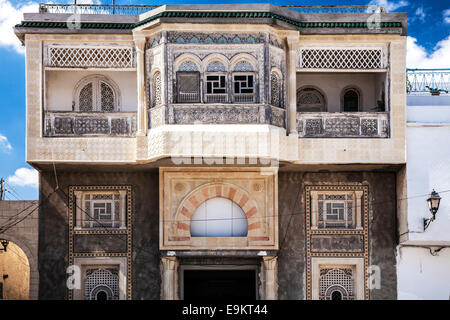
296;112;389;138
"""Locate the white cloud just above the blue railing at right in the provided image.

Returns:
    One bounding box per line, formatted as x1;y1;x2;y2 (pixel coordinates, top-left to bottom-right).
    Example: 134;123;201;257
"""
406;36;450;69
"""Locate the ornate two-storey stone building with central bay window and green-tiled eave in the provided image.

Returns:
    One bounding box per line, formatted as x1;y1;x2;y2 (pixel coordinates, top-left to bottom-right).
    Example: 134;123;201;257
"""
15;4;407;300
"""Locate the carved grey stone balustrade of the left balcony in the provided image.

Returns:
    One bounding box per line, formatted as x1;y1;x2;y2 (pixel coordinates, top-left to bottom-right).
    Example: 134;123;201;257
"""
44;111;136;137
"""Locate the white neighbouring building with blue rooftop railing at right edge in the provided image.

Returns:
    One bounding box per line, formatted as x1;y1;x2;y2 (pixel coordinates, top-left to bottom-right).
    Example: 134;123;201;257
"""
397;69;450;300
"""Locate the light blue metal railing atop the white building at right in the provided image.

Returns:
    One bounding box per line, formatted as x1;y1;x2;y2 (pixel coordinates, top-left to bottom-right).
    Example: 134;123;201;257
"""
406;69;450;95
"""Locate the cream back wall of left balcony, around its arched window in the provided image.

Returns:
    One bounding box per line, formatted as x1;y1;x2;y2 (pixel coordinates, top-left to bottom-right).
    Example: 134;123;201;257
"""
46;71;137;112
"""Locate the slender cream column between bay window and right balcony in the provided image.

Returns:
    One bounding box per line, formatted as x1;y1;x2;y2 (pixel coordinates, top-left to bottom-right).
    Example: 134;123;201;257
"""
286;35;298;136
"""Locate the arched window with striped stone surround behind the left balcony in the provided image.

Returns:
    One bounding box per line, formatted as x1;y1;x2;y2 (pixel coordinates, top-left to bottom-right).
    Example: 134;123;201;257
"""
72;74;121;112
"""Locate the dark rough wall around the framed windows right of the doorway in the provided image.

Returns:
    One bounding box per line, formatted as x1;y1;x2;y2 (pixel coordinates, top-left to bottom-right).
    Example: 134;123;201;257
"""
278;172;397;300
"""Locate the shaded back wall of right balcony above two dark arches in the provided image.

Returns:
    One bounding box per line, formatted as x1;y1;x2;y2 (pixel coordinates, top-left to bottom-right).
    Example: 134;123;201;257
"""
297;72;385;112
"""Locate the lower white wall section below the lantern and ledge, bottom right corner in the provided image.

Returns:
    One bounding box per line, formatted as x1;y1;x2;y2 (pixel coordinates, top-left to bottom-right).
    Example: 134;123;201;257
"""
397;247;450;300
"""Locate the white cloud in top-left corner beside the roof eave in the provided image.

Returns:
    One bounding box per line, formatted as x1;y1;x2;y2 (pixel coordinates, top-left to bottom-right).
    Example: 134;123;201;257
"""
0;0;39;54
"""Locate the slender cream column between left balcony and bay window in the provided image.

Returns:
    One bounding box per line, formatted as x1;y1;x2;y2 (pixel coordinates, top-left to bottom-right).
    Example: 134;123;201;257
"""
134;36;147;136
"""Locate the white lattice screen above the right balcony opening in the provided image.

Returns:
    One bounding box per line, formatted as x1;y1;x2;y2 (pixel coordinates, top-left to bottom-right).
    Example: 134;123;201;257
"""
298;48;387;69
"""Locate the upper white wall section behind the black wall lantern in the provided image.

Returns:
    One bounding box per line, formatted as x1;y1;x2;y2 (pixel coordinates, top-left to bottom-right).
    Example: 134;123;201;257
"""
406;102;450;240
